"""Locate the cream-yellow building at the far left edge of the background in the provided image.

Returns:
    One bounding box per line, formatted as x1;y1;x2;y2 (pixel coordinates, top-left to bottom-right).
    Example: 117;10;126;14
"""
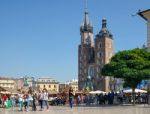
0;78;16;89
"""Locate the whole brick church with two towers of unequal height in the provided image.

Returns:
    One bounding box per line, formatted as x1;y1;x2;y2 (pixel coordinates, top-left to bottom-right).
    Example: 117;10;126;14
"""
78;10;113;91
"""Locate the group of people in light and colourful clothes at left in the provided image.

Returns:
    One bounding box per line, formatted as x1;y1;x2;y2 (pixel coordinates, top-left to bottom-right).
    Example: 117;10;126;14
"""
0;89;49;111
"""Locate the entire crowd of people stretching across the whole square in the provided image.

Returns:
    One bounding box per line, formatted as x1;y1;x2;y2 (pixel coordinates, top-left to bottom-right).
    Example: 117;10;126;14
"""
0;88;148;111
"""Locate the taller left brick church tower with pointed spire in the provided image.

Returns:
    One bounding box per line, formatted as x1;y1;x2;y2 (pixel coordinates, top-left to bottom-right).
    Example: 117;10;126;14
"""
78;9;94;90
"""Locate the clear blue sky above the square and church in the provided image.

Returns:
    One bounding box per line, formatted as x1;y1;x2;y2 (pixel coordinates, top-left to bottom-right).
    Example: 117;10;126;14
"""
0;0;150;82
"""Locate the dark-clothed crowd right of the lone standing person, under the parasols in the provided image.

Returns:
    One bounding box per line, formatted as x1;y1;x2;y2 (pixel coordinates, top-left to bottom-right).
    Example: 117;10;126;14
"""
76;91;148;105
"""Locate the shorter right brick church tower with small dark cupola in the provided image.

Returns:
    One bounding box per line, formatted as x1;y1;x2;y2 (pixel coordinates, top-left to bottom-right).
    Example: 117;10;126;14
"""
95;19;113;91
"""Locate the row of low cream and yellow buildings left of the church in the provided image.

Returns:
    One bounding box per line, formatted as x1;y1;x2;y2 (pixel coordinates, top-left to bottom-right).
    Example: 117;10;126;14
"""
0;76;78;92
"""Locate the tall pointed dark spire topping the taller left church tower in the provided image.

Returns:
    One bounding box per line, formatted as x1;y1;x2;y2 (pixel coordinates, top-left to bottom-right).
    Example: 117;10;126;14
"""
80;0;93;33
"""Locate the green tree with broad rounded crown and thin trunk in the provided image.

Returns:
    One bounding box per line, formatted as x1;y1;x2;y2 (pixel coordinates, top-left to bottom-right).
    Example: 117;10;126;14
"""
101;48;150;105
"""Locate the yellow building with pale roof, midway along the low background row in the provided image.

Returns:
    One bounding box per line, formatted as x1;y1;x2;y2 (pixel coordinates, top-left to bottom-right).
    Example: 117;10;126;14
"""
36;78;59;92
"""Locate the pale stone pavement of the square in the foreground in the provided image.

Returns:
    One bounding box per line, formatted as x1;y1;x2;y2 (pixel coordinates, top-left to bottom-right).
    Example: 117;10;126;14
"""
0;105;150;114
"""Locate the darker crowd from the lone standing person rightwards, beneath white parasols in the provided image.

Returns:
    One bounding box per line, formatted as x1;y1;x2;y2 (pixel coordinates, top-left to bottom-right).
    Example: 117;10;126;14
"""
50;90;148;108
